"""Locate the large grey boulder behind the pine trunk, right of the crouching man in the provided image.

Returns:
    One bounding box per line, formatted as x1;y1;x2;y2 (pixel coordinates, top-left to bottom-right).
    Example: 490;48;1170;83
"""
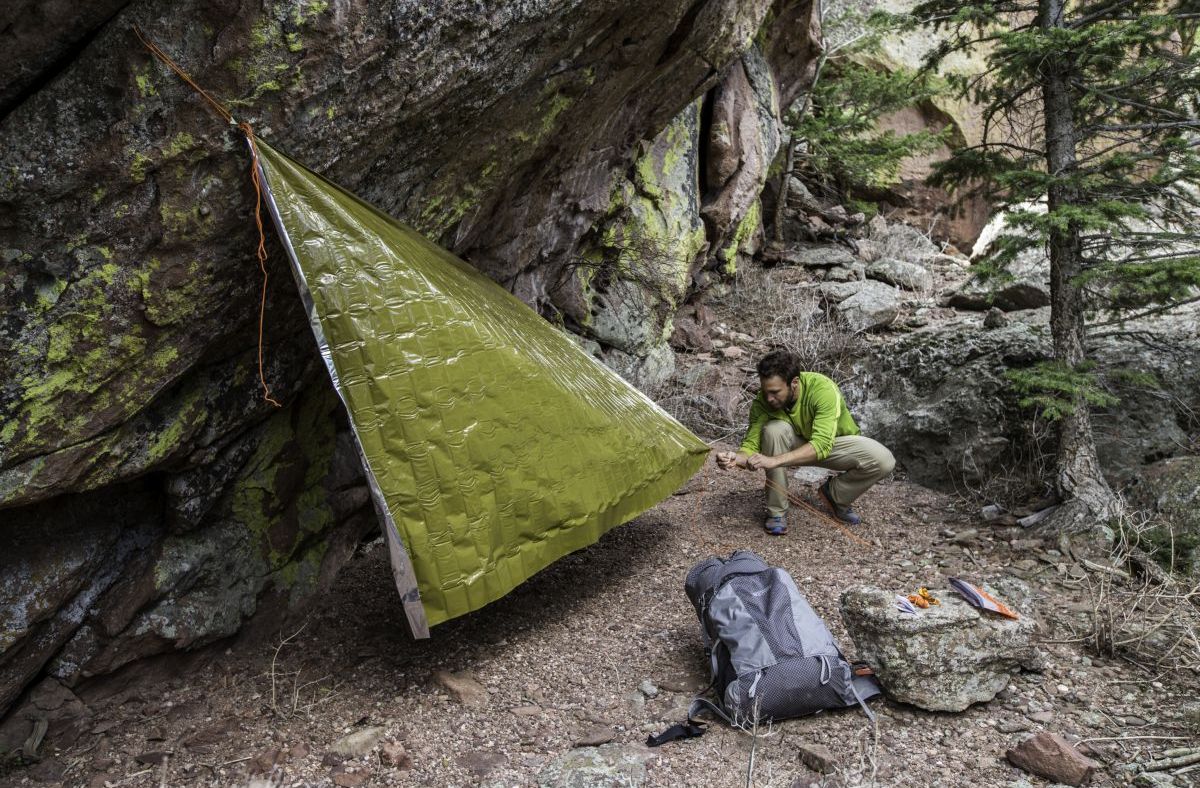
854;307;1200;489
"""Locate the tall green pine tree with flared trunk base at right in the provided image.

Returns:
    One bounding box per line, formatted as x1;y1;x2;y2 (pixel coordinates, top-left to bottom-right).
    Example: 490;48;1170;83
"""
913;0;1200;530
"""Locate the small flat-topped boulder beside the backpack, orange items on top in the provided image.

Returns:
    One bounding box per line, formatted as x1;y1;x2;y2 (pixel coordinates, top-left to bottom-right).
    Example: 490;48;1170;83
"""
841;579;1037;711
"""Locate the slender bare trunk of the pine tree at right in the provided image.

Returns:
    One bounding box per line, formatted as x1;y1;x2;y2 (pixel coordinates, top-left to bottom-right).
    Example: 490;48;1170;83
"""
1038;0;1117;531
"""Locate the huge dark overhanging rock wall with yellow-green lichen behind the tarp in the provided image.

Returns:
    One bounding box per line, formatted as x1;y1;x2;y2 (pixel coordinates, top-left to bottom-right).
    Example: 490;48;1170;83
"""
0;0;814;712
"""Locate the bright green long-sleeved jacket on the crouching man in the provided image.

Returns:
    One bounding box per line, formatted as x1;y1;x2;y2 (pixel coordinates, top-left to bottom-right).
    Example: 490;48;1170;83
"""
738;372;858;459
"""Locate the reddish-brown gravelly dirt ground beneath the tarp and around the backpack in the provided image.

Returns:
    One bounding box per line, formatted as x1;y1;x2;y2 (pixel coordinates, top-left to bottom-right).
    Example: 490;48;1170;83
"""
5;462;1200;787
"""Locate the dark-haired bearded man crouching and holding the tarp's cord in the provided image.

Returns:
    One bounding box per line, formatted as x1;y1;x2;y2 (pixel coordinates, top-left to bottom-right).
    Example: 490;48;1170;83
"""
716;350;895;536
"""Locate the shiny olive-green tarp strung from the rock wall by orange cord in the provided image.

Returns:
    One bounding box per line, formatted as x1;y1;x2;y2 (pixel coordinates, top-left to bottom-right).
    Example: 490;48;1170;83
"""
258;142;708;637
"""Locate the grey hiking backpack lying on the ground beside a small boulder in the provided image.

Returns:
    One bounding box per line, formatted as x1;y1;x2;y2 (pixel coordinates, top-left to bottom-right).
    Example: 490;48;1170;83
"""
685;551;881;724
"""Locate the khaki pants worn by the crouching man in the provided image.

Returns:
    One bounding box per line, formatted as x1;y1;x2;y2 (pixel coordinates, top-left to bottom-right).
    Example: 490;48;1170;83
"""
760;419;896;516
